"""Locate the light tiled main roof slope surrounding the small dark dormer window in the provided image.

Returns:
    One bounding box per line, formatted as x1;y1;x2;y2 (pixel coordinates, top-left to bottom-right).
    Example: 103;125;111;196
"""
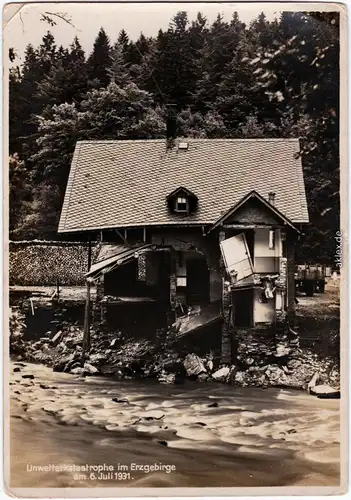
59;139;308;232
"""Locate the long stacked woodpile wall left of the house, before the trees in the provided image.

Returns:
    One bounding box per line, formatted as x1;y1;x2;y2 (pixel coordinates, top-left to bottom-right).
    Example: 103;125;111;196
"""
9;240;96;286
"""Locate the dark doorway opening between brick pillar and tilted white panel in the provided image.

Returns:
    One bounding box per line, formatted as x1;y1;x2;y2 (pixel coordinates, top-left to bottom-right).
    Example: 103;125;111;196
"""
186;257;210;305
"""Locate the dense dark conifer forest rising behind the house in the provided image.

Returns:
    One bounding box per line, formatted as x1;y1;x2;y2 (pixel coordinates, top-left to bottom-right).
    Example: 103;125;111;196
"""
9;11;340;264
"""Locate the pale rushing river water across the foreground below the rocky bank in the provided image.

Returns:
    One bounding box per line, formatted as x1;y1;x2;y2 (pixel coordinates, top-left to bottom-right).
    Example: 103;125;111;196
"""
10;363;340;488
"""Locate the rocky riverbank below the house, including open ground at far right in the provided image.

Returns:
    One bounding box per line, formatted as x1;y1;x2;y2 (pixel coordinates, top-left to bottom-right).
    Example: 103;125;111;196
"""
11;282;340;391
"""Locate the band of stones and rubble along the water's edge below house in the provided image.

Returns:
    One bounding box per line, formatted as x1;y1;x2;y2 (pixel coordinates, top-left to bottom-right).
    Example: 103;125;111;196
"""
10;300;340;397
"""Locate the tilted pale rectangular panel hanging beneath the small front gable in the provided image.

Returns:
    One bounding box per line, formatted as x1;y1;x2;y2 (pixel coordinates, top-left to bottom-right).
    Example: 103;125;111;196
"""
220;233;253;284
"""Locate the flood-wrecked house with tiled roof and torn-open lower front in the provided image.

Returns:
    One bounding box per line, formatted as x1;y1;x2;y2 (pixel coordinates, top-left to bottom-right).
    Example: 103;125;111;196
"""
59;139;308;361
